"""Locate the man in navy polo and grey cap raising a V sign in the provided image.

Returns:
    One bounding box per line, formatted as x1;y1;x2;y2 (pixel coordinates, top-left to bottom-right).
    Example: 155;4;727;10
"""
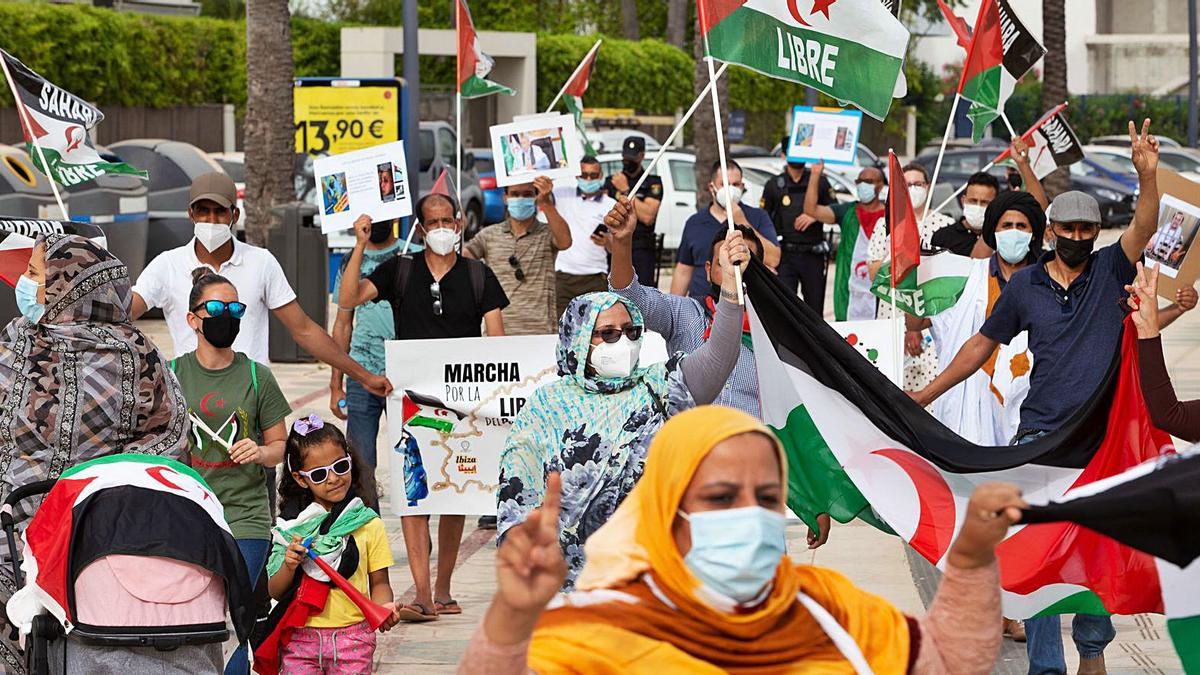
910;119;1158;674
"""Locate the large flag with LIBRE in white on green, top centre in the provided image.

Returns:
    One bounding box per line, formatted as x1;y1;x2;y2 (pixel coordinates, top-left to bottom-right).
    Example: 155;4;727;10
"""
696;0;908;120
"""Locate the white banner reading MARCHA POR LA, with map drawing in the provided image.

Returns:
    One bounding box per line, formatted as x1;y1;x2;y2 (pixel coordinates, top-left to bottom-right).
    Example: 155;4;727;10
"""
386;333;667;515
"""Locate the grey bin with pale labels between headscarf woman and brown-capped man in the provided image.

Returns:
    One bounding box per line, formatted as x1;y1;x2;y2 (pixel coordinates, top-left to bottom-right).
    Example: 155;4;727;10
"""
70;175;150;282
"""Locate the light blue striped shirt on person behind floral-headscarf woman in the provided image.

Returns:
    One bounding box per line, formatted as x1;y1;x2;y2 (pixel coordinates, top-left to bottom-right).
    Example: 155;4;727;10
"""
608;274;761;418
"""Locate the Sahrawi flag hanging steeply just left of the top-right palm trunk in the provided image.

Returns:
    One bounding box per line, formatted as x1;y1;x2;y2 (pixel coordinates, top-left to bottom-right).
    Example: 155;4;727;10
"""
959;0;1046;143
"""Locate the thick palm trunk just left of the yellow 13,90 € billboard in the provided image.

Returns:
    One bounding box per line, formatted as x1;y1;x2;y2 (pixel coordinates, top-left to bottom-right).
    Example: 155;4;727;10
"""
245;0;295;246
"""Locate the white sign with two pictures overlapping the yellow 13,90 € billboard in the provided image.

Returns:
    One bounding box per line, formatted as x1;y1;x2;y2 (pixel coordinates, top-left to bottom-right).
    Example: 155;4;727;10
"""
312;141;413;233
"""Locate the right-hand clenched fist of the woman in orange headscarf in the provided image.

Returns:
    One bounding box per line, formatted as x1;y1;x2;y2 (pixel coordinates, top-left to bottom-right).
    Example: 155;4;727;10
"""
947;483;1028;569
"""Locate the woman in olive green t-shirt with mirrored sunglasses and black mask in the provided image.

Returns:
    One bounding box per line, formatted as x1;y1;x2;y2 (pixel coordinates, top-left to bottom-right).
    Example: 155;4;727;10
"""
172;268;292;675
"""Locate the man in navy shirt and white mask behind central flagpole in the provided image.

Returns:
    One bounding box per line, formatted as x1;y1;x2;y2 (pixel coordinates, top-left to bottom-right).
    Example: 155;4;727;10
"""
671;160;779;301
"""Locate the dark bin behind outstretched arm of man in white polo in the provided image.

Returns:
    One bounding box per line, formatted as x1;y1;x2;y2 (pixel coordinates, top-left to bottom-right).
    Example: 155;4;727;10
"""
266;202;329;363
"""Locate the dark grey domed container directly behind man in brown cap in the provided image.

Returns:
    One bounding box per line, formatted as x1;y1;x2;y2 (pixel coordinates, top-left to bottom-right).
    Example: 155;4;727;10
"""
108;138;222;263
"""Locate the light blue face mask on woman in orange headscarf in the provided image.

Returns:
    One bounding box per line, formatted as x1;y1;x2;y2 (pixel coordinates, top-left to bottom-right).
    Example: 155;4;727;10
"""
679;506;787;604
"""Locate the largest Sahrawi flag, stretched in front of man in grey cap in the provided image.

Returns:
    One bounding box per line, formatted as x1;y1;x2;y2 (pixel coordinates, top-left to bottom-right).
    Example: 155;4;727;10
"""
746;265;1200;671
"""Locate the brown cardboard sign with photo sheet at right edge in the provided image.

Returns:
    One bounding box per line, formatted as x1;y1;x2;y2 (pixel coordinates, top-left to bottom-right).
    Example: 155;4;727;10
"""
1144;168;1200;296
